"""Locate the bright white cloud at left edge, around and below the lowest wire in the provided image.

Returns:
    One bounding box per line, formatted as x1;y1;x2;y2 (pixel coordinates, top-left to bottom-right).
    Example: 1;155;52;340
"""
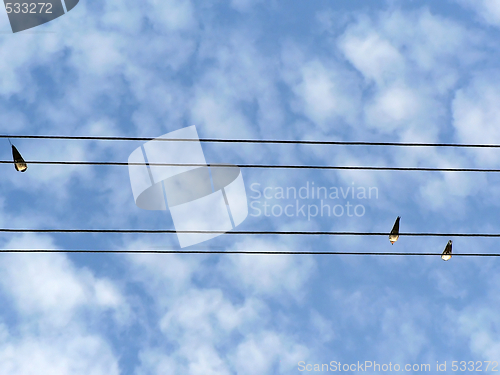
0;234;128;328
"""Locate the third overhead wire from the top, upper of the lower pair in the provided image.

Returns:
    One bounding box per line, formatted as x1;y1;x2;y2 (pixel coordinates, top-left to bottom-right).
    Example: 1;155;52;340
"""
0;228;500;237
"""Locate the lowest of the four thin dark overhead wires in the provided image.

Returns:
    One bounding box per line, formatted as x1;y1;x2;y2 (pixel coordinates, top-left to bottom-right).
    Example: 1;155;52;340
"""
0;249;500;257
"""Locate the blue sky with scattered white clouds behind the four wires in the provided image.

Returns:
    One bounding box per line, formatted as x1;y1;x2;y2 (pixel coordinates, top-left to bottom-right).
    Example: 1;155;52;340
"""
0;0;500;375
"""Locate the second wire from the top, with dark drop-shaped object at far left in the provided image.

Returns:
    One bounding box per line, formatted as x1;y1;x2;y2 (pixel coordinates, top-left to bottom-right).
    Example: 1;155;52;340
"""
0;160;500;173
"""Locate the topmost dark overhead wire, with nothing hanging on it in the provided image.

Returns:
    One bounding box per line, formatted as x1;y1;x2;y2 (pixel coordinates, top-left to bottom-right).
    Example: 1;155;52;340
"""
0;135;500;148
